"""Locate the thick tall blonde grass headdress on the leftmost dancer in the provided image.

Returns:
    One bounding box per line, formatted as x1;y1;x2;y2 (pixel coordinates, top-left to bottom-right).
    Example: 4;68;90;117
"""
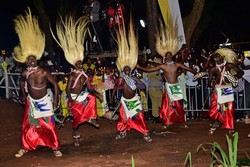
14;8;45;63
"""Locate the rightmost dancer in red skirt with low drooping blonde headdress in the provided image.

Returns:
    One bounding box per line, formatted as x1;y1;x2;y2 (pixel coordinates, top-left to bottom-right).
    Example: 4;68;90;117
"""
208;48;244;134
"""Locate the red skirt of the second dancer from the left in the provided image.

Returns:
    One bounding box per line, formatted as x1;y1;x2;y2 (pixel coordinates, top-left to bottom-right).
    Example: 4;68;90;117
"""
69;94;97;128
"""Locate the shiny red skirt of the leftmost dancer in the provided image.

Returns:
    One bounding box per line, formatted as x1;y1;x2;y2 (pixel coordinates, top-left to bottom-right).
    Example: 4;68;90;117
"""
22;100;60;151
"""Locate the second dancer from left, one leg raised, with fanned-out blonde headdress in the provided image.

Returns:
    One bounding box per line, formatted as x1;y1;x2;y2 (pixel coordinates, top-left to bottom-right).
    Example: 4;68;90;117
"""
52;16;99;146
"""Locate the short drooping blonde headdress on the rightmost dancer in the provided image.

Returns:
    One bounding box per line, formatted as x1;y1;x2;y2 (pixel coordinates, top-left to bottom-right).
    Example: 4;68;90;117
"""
215;48;237;63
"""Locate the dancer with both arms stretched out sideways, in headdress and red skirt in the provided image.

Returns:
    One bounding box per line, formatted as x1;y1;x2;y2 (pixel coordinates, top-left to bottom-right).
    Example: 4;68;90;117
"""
137;20;196;128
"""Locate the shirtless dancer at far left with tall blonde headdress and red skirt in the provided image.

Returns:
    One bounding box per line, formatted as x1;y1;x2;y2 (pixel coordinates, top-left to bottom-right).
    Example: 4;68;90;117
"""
14;9;62;157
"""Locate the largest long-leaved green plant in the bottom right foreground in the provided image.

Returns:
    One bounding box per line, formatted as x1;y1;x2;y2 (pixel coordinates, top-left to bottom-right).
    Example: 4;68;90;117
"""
197;132;239;167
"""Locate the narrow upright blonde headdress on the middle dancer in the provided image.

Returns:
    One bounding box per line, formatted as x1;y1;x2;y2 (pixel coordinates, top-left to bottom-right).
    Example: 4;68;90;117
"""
116;18;138;71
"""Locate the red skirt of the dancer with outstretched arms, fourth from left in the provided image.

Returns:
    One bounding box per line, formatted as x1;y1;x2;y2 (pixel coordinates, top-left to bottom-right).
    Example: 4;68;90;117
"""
160;92;185;125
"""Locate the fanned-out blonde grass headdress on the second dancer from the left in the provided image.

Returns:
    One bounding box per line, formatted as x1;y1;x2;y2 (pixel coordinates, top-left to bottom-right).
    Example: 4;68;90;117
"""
50;15;89;66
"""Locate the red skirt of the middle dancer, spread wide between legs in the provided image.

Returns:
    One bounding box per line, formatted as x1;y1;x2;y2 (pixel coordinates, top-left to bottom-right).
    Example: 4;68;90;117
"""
116;104;149;135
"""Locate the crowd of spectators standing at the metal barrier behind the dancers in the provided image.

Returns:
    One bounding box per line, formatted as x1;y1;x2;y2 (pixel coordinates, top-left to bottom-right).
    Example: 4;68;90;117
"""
0;45;250;122
